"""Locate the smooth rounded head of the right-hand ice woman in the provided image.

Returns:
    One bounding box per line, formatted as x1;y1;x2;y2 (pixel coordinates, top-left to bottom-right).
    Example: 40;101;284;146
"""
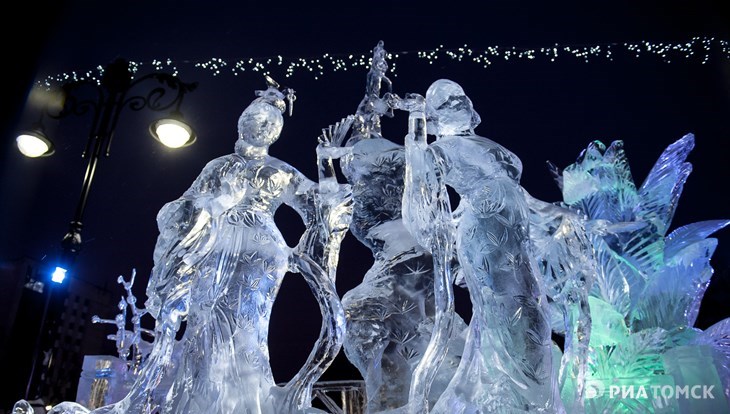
426;79;481;136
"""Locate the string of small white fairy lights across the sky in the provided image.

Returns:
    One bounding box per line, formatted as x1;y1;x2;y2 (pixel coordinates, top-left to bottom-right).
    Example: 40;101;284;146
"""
39;36;730;88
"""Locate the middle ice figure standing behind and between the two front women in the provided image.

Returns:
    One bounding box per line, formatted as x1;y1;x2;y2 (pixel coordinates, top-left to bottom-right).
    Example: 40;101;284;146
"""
318;42;465;412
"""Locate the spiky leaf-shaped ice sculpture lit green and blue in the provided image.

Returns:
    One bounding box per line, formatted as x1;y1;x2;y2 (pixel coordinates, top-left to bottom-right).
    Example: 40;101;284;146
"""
553;134;730;413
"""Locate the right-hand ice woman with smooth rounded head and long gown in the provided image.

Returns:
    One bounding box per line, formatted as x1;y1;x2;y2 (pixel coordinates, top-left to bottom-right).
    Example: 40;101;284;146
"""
393;79;562;413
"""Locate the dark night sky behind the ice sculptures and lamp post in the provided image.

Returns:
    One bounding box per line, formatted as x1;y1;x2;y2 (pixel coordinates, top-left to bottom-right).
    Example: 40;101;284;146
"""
0;1;730;381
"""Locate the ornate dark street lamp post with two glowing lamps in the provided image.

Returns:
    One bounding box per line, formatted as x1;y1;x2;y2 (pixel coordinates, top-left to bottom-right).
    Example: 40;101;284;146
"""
17;59;197;398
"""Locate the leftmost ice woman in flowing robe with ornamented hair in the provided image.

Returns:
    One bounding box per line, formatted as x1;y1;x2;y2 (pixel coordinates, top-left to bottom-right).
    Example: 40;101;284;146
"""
102;79;348;414
